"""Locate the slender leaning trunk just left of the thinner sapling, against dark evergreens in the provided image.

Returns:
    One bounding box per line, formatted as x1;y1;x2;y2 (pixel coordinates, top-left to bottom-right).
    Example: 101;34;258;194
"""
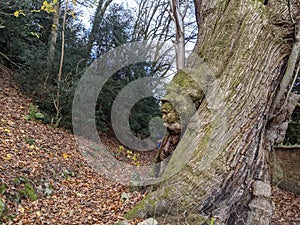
44;1;60;87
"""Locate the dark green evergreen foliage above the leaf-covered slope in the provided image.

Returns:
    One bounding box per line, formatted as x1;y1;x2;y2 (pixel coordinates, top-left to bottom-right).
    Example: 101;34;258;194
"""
0;0;166;138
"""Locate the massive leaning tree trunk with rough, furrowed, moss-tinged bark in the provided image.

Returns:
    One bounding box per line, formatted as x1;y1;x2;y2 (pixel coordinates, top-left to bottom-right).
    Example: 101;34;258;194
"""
127;0;299;225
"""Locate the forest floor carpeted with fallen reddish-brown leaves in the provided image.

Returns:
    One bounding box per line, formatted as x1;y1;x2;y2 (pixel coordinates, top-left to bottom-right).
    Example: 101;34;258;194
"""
0;66;300;225
